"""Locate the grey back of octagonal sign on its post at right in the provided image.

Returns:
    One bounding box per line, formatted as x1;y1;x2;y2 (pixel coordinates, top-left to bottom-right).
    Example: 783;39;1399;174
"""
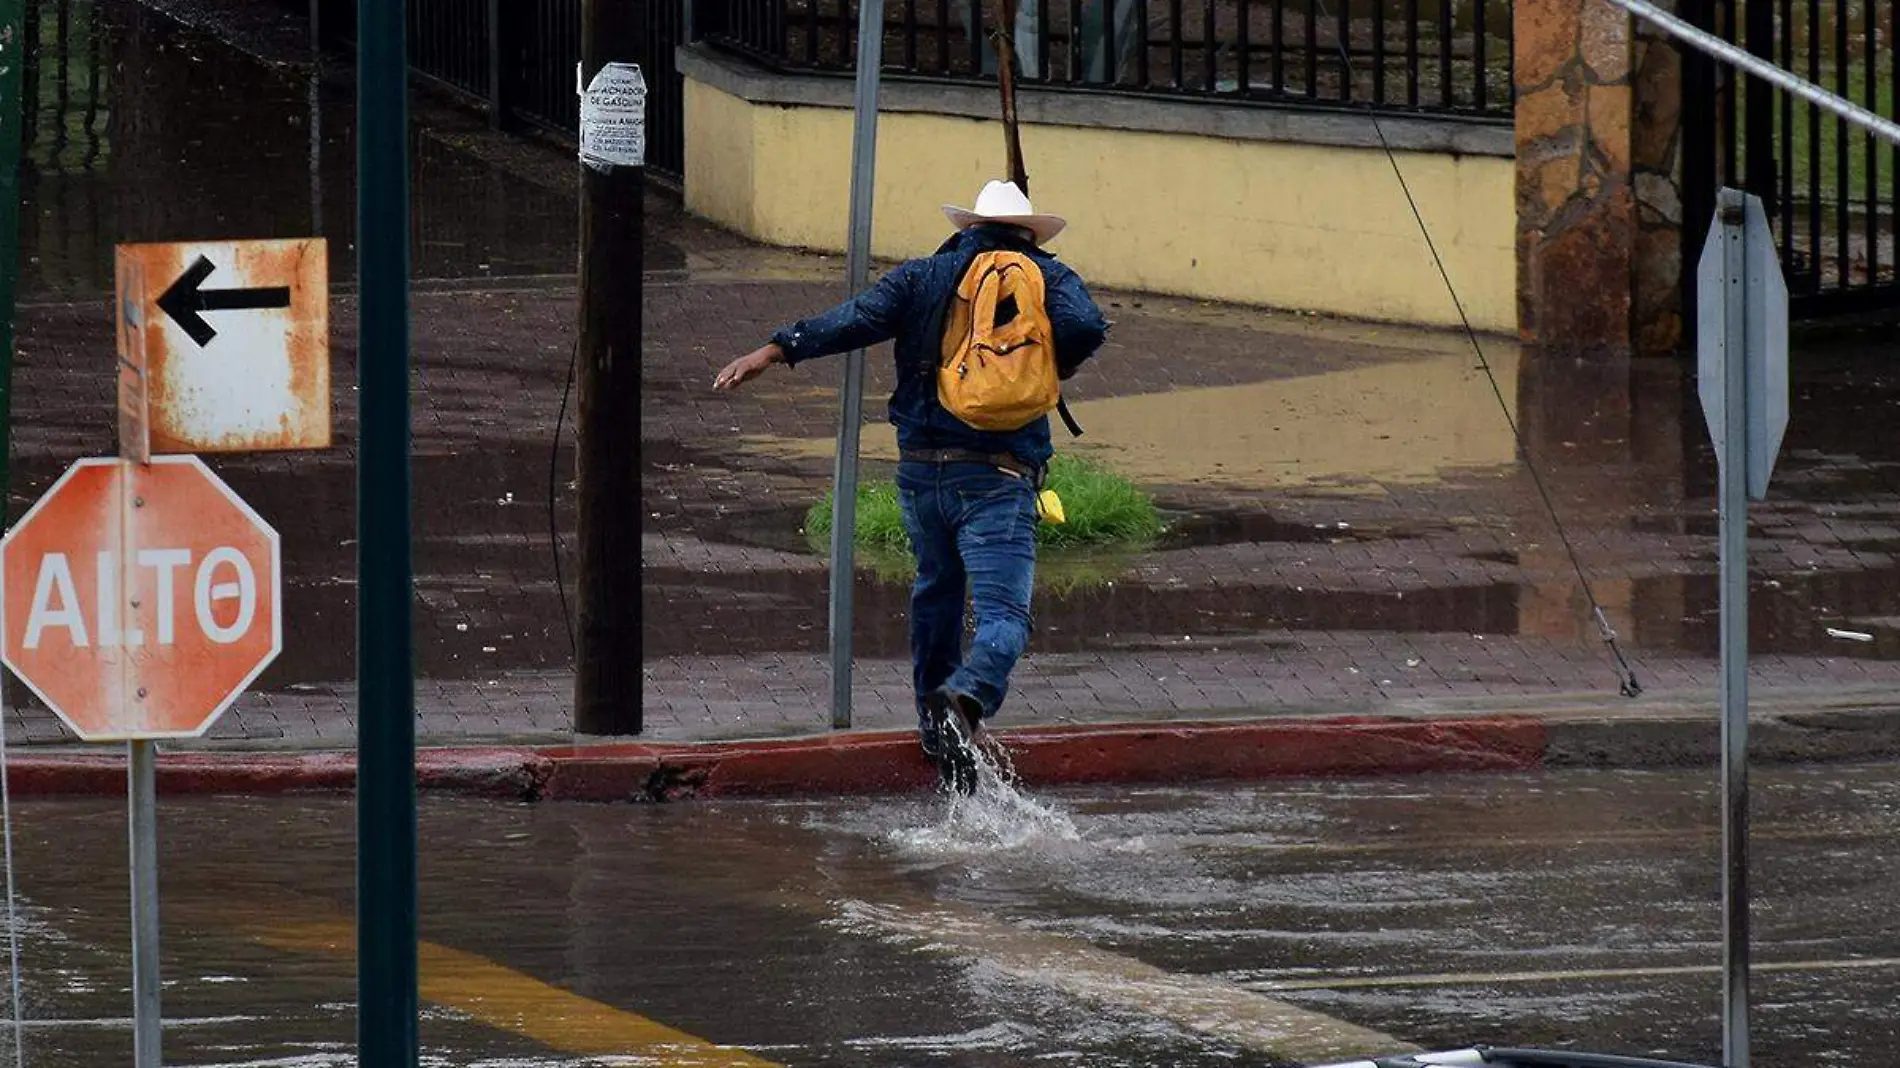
1695;188;1788;1068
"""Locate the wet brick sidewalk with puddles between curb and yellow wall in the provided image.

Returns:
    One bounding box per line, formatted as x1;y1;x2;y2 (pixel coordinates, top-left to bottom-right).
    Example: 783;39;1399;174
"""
10;0;1900;745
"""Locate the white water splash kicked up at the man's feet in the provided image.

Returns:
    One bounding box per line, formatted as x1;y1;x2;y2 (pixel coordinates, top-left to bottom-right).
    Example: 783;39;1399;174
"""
889;739;1083;855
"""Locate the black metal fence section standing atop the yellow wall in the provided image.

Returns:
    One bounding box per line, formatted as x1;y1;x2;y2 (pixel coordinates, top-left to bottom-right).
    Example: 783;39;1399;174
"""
695;0;1512;120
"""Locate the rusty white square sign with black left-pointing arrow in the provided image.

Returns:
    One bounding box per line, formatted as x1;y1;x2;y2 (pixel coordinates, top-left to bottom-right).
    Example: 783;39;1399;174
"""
118;238;331;456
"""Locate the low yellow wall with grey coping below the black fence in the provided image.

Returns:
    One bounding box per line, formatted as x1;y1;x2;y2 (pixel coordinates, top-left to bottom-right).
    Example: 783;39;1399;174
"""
686;78;1516;333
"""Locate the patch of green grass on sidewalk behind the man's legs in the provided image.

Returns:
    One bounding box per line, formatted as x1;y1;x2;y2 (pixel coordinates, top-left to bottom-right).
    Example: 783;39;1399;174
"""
806;448;1163;566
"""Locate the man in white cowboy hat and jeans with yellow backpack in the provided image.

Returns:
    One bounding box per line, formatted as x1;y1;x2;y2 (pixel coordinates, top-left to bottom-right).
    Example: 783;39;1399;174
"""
714;182;1108;792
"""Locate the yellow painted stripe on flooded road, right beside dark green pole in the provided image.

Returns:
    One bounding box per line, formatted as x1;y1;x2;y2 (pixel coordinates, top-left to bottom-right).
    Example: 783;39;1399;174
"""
247;920;779;1068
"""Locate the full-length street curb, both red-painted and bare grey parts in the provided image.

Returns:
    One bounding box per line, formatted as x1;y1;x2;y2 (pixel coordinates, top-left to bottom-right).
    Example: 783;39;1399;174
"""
8;707;1900;802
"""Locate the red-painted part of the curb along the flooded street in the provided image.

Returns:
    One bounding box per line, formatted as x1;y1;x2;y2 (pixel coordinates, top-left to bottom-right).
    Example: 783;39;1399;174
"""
10;716;1549;802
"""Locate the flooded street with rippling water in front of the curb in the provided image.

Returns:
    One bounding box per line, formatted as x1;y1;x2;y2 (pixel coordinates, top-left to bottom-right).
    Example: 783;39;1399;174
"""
3;766;1900;1068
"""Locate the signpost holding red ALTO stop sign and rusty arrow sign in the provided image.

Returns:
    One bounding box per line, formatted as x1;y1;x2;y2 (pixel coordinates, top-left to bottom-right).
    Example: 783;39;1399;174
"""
0;230;315;1068
